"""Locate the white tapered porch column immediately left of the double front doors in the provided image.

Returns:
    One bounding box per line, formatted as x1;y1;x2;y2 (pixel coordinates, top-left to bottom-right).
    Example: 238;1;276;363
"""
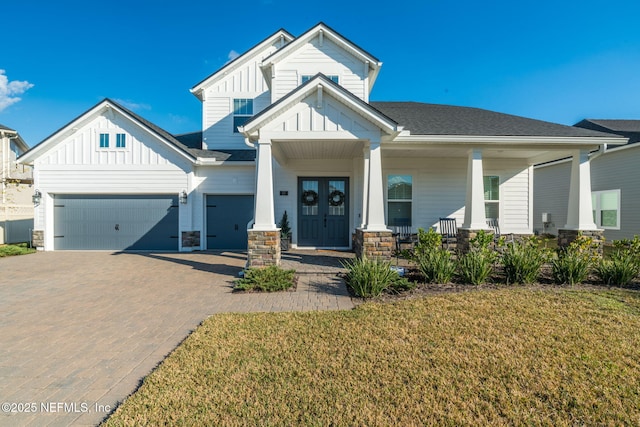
252;139;277;231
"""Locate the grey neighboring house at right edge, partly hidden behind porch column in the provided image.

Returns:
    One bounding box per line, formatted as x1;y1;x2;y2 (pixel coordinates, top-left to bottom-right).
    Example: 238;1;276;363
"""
534;119;640;241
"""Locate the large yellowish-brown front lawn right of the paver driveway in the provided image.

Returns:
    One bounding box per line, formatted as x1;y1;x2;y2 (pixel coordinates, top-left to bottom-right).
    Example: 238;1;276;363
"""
106;288;640;426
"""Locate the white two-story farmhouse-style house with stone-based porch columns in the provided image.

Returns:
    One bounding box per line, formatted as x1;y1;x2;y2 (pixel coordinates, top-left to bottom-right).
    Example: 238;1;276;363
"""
22;23;626;265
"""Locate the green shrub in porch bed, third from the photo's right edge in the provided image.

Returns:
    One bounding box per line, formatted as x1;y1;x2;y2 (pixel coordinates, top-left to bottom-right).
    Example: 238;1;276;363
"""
502;236;549;284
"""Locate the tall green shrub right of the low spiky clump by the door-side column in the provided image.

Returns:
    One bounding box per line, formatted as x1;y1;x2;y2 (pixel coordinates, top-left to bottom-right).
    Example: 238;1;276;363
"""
413;228;456;283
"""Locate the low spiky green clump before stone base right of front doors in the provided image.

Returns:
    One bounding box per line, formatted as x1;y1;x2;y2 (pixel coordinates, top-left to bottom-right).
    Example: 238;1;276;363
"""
342;256;408;298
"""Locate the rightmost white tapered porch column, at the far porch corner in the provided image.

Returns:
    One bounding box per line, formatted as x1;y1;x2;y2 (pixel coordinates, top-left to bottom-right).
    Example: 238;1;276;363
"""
564;150;598;230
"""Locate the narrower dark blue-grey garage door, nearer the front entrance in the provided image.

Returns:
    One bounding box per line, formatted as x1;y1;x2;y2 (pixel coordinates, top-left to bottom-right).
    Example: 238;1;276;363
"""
207;195;253;249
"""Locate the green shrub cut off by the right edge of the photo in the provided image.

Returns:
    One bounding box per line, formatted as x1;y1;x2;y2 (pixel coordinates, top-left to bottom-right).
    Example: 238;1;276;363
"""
594;236;640;286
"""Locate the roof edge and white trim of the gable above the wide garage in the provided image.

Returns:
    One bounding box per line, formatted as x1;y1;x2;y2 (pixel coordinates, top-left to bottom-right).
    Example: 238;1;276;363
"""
20;98;196;162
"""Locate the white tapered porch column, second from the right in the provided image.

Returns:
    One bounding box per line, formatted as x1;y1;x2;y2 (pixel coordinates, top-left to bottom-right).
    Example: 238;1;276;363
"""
462;148;488;230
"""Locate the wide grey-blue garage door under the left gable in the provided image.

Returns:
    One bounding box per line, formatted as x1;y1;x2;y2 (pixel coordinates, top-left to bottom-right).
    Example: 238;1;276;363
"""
53;194;178;251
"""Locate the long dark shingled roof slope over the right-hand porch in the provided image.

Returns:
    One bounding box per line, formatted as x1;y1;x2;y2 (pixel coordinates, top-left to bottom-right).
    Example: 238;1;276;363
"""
371;102;622;142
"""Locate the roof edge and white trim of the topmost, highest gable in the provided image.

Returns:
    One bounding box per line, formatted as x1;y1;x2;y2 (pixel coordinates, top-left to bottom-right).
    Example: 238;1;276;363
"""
261;22;382;89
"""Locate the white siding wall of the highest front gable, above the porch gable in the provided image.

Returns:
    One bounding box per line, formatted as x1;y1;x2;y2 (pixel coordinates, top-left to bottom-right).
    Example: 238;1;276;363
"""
272;37;369;102
